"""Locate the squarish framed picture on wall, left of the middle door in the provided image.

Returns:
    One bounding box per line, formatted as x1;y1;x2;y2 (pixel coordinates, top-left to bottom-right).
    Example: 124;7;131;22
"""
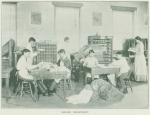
31;12;42;25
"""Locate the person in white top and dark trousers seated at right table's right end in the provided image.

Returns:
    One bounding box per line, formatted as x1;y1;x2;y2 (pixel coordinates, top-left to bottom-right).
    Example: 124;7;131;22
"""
112;51;130;93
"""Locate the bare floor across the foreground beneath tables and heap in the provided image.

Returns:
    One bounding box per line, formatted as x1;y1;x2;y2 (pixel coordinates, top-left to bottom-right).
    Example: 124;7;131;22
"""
1;82;148;109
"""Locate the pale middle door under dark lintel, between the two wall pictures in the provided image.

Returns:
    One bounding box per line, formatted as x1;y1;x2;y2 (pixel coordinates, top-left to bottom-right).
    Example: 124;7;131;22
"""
55;7;79;53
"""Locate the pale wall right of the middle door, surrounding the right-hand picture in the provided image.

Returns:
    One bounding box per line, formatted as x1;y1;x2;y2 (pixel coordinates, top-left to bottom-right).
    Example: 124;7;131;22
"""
80;2;148;45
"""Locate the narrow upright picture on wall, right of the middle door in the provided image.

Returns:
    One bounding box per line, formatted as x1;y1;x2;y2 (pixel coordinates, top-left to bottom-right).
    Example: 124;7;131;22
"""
93;12;102;26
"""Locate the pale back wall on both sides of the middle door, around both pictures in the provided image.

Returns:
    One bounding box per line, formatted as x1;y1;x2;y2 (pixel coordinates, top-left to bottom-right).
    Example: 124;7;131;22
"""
17;2;148;47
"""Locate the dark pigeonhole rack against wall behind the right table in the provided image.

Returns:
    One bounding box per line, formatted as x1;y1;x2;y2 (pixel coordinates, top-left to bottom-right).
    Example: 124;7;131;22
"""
88;35;113;64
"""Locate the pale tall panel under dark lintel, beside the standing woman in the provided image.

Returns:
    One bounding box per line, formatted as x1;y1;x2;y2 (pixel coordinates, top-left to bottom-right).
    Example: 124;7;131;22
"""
113;10;133;50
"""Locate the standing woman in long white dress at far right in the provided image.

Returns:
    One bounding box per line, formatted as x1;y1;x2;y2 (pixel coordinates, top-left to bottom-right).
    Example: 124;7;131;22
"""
135;36;148;81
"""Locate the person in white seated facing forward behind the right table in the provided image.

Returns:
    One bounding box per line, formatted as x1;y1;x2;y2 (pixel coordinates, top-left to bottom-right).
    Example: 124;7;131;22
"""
83;50;99;80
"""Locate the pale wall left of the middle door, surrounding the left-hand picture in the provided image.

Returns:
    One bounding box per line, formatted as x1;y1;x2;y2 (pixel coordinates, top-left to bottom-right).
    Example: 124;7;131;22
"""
17;2;55;46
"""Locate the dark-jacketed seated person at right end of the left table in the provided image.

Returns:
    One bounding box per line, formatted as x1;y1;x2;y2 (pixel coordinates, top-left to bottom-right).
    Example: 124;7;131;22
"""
45;49;71;93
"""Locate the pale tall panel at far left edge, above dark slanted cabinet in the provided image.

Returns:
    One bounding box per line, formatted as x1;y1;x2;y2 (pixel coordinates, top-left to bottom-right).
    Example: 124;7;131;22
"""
1;3;16;46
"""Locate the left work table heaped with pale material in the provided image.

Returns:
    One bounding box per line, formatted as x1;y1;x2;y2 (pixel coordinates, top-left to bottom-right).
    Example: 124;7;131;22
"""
30;69;67;99
